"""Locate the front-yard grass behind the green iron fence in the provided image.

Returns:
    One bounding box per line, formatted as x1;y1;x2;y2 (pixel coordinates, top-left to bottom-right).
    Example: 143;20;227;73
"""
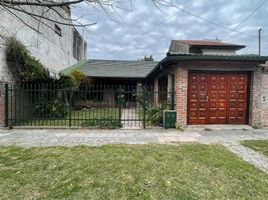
17;108;119;126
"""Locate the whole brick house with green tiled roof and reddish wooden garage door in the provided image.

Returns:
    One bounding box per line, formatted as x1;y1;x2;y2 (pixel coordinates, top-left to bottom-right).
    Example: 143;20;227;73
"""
63;40;268;126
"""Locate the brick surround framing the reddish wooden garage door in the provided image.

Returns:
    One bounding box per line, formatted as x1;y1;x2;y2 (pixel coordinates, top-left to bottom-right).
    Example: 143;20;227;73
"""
172;61;268;126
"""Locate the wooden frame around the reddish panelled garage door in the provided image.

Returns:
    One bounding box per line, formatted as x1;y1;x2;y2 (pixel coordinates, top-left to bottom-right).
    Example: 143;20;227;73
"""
186;70;251;125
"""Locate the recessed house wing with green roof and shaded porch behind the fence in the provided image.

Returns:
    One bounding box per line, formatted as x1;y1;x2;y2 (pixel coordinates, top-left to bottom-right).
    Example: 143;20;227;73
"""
61;59;158;106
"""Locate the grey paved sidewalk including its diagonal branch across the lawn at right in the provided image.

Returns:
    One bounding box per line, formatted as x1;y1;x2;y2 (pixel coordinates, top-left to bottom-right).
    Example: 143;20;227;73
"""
0;127;268;172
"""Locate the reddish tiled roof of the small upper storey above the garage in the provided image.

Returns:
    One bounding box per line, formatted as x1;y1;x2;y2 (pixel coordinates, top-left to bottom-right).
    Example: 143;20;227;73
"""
174;40;245;47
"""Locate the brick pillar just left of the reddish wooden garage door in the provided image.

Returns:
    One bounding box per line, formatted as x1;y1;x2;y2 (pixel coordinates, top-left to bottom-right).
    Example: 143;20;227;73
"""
175;66;188;126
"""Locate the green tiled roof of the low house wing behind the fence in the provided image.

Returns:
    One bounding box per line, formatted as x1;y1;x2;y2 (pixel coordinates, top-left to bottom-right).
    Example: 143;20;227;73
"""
61;59;158;78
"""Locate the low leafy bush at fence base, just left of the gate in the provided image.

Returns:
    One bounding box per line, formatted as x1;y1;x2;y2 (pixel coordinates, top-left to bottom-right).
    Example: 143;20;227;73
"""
81;116;122;129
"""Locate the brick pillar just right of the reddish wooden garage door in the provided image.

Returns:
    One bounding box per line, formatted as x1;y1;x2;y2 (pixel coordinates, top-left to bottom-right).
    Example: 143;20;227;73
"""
249;67;262;127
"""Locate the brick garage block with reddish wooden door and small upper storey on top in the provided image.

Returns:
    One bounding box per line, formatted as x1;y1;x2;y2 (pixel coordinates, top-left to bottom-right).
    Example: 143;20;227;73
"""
147;40;268;126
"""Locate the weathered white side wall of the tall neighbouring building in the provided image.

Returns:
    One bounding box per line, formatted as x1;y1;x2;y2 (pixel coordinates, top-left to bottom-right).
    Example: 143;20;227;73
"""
0;7;86;81
